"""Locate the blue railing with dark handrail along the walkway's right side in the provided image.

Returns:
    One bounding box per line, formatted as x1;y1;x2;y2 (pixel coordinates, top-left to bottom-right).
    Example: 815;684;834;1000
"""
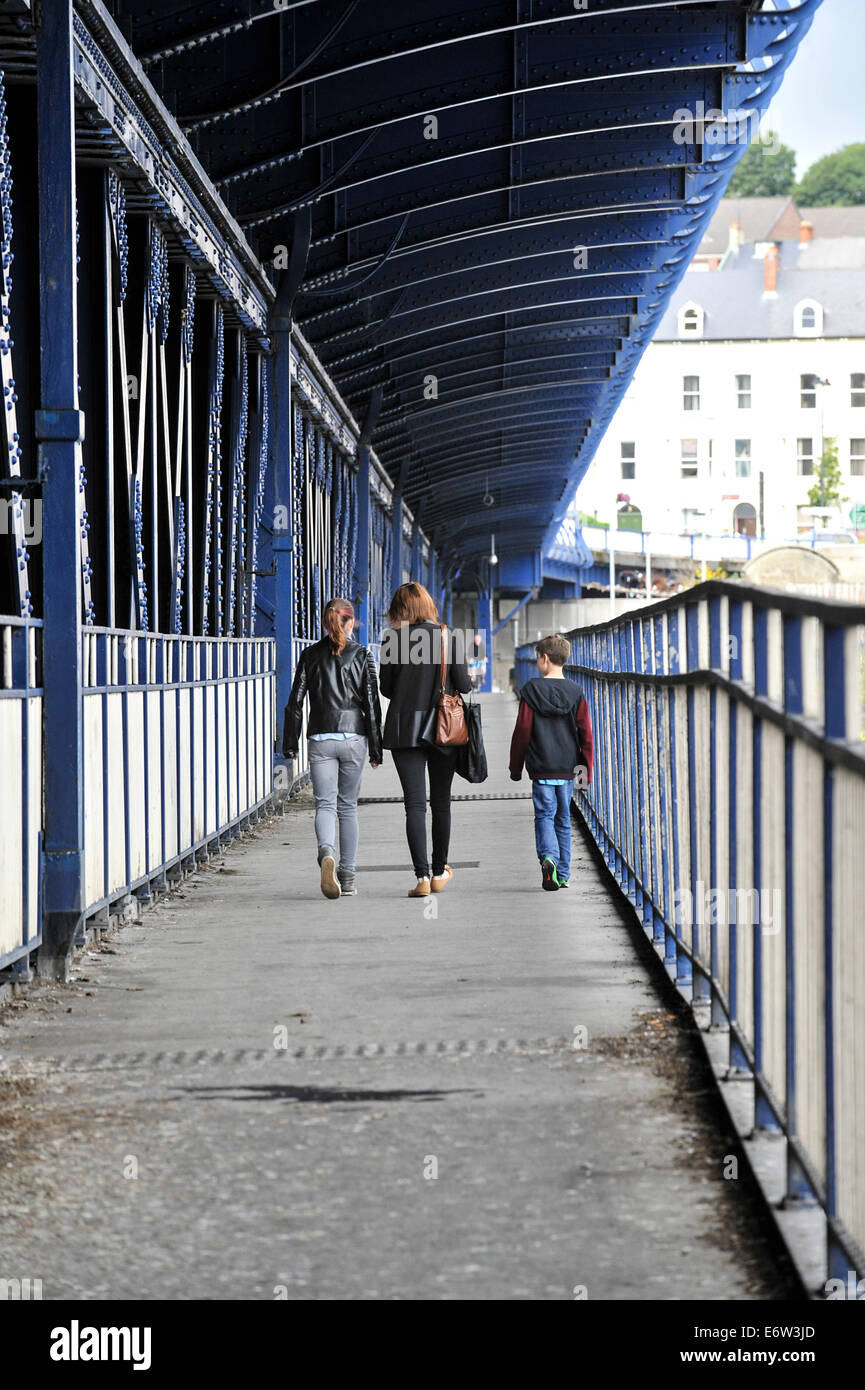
516;581;865;1277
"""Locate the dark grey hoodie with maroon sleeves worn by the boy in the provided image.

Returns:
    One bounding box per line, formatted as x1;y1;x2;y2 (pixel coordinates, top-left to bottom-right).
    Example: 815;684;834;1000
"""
510;676;594;783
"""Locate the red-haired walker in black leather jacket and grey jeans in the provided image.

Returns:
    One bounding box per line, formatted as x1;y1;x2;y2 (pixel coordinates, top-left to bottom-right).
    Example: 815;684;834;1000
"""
282;599;381;898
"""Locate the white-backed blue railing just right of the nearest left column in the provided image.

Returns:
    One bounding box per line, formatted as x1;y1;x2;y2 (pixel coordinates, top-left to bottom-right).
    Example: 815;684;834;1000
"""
82;627;275;915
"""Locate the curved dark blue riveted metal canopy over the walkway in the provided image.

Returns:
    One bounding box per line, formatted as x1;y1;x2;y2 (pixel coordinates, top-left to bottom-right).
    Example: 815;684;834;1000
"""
57;0;819;559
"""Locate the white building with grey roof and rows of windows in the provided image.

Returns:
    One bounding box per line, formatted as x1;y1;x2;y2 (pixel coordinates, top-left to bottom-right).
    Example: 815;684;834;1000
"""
577;238;865;542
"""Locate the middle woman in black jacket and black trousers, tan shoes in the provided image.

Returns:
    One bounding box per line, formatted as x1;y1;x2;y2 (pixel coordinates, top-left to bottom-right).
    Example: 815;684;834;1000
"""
381;584;471;898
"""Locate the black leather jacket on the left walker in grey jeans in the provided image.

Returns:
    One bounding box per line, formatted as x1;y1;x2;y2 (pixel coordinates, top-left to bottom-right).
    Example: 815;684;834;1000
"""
282;637;381;763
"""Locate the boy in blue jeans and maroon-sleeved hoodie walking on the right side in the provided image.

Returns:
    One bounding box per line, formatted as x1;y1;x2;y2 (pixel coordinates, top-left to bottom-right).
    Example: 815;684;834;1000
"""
510;632;594;892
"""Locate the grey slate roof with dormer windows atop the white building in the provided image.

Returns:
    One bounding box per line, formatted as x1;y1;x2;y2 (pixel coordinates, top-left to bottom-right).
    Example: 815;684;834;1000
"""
655;238;865;342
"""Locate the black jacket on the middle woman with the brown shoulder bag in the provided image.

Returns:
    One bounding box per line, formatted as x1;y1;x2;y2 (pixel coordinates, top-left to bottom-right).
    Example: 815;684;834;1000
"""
380;623;471;748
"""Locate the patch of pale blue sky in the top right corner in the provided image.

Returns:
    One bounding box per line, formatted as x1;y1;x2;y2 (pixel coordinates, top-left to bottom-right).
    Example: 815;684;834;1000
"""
763;0;865;178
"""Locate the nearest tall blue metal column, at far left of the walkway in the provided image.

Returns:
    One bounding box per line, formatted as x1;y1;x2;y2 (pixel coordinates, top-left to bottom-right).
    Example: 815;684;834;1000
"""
36;0;83;979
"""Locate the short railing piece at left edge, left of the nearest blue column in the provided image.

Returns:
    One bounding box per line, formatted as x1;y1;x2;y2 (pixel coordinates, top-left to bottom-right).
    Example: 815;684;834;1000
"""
0;617;43;970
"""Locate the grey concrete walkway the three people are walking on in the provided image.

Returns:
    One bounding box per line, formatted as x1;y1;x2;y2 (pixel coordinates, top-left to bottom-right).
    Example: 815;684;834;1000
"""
0;696;791;1300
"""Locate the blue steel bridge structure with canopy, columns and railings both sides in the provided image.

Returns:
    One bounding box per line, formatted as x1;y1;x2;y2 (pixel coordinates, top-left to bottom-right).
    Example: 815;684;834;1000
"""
0;0;865;1289
